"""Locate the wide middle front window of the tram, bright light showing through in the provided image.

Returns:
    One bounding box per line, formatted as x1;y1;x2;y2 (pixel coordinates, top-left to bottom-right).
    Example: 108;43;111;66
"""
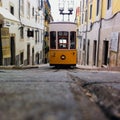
58;31;68;49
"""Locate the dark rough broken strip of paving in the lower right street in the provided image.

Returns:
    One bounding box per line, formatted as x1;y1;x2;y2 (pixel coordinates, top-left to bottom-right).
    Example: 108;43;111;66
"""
69;74;120;120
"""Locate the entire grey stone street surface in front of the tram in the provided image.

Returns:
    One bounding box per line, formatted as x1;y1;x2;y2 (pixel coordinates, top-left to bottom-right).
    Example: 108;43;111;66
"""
0;65;120;120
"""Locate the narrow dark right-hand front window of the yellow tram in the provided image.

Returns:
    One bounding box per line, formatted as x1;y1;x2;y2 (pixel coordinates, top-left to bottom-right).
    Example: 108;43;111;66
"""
70;31;76;49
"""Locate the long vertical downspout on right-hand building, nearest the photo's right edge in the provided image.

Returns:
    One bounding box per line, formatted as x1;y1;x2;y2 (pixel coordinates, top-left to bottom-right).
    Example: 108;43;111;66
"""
97;0;103;67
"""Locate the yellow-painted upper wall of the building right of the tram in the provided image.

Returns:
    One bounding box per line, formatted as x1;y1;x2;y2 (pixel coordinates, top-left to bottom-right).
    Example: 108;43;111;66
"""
78;0;120;26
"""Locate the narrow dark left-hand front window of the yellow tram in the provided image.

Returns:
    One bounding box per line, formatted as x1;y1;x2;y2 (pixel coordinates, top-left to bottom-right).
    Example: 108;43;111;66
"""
50;31;56;49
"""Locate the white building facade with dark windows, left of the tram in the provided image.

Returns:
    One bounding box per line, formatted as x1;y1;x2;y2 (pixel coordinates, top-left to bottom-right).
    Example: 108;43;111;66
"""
0;0;44;66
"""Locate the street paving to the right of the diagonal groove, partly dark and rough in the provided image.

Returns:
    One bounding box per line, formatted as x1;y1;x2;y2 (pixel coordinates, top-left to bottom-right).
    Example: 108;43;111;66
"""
71;70;120;120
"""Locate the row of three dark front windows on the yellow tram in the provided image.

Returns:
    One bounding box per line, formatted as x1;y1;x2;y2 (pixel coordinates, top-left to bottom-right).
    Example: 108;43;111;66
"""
50;31;76;49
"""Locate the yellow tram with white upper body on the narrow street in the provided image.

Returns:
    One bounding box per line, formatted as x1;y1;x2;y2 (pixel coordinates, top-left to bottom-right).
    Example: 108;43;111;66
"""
49;22;77;66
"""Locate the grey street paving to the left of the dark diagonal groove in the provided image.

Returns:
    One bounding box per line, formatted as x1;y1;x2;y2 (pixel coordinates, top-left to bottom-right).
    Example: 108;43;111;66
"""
0;67;110;120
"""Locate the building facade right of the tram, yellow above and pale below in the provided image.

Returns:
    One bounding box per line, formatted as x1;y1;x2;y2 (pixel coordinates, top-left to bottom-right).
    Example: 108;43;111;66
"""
78;0;120;67
